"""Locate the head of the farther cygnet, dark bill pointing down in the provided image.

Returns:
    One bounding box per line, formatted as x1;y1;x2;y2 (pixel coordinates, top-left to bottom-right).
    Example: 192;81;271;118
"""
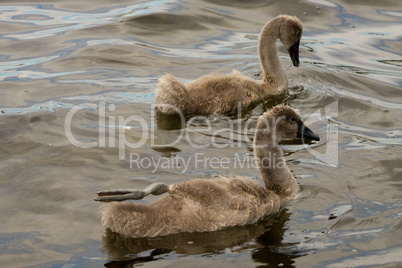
278;15;303;67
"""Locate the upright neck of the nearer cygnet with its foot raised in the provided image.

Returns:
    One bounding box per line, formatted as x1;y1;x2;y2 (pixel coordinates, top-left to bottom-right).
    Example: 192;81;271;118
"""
254;121;299;198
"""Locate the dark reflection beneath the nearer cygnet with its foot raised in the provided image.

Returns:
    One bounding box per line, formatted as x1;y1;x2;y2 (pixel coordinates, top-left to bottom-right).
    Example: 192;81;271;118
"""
103;210;303;267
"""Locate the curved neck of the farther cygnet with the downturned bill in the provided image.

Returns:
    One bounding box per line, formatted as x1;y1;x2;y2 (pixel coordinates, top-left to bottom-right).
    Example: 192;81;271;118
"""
258;18;288;94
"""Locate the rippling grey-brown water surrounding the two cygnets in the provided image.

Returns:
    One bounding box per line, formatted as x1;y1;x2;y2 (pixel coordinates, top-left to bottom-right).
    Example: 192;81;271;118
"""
0;0;402;267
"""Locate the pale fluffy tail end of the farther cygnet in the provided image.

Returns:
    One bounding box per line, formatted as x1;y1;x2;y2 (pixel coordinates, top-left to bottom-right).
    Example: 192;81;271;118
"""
155;74;190;114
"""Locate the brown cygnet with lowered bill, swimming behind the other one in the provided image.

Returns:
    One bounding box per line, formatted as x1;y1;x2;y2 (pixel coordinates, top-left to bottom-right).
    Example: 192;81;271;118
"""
155;15;303;115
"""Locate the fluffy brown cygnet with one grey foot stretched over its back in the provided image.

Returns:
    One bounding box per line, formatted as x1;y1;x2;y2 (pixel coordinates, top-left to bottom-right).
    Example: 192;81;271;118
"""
95;106;320;237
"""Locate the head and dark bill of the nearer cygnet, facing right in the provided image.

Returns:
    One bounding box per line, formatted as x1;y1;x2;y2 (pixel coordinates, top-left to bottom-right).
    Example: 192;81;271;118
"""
257;105;320;142
